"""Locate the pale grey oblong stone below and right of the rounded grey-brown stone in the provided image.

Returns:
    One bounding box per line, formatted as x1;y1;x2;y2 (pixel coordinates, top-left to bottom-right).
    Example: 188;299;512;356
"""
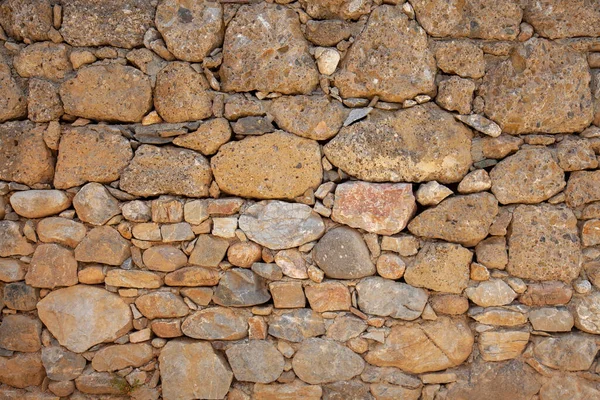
356;276;428;321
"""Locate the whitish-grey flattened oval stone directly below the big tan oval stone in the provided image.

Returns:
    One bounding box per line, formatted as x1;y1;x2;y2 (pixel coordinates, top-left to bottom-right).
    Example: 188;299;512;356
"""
239;201;325;250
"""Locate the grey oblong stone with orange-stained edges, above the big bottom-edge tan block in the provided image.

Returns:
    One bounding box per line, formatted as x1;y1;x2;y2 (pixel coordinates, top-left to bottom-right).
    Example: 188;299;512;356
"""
181;307;250;340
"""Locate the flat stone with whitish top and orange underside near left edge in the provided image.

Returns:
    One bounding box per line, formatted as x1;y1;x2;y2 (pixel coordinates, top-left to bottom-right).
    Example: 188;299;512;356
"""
10;190;71;218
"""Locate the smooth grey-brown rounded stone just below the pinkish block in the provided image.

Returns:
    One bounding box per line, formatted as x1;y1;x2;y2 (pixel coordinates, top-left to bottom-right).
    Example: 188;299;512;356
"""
313;227;376;279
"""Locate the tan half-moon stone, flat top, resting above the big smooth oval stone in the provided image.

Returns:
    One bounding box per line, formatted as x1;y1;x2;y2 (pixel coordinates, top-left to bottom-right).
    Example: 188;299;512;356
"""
270;96;348;140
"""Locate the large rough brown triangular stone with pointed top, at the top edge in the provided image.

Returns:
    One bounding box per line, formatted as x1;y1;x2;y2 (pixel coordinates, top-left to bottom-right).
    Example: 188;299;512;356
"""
334;5;436;102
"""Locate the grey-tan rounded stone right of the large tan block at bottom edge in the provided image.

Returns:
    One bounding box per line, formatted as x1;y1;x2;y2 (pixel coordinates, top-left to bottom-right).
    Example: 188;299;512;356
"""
225;340;284;383
